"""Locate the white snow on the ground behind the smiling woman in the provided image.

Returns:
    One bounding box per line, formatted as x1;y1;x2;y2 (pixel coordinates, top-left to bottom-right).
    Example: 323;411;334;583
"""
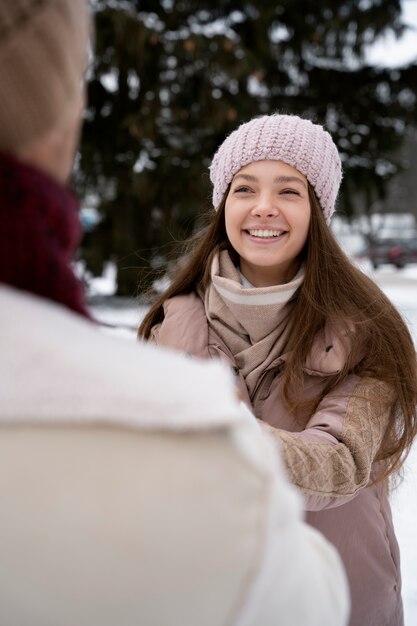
91;265;417;626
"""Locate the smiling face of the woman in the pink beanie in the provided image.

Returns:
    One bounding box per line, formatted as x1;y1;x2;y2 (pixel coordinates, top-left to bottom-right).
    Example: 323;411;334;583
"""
225;161;311;287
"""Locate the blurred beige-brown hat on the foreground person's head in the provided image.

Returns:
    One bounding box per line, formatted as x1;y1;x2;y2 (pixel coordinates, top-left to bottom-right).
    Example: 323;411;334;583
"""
0;0;90;153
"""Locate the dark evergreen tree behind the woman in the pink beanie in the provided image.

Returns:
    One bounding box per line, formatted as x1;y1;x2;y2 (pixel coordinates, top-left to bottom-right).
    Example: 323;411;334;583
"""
76;0;417;295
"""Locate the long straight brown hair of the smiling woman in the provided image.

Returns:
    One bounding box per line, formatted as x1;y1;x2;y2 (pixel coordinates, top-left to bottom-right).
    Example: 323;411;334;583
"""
138;185;417;478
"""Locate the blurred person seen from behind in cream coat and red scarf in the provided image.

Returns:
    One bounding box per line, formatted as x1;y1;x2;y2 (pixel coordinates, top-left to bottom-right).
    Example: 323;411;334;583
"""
0;0;348;626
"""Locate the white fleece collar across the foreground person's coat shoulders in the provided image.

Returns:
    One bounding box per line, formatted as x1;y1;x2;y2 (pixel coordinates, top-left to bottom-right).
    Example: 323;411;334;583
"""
0;285;242;430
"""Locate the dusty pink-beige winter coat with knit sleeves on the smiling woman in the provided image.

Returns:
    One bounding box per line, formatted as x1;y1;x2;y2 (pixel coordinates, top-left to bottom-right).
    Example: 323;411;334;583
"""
152;294;403;626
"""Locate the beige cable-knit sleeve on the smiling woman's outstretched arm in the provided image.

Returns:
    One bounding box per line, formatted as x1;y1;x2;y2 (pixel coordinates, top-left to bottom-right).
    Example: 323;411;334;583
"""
262;378;393;511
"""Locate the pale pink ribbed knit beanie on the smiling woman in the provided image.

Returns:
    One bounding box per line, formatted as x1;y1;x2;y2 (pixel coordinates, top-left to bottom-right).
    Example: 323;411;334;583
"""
210;114;342;224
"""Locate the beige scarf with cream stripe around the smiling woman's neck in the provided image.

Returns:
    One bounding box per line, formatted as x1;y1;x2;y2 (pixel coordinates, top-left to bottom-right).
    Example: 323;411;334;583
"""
204;250;304;397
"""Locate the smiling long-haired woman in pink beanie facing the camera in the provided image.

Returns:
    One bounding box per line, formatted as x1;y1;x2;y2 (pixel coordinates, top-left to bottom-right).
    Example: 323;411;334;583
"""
139;115;417;626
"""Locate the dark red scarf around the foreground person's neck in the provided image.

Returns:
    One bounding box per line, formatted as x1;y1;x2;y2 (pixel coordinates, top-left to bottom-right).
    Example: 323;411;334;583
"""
0;154;90;317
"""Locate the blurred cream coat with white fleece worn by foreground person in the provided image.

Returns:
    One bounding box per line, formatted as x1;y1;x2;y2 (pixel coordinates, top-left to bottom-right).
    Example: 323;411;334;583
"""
0;285;348;626
